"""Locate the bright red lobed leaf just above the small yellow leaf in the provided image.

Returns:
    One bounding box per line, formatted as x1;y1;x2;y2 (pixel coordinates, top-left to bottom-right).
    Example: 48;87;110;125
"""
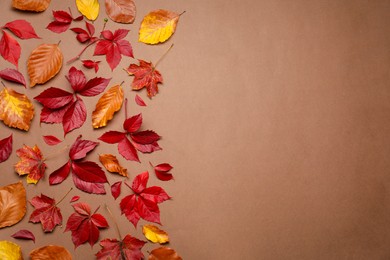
120;172;171;227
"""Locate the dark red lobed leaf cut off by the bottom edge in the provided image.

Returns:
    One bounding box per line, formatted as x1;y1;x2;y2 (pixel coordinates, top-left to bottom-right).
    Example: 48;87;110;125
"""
96;234;146;260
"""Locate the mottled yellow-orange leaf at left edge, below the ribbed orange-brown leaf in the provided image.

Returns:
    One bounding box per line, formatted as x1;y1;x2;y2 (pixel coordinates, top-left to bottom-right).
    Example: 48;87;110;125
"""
0;87;34;131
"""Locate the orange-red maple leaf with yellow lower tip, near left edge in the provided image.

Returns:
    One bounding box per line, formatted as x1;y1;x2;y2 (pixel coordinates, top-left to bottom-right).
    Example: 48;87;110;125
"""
14;145;47;184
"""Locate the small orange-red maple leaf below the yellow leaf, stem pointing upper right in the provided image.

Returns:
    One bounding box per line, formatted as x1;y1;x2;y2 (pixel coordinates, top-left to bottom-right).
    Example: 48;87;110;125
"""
127;60;163;97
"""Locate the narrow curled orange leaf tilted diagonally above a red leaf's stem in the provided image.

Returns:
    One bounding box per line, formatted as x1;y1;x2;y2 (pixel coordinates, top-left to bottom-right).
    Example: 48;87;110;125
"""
92;85;123;128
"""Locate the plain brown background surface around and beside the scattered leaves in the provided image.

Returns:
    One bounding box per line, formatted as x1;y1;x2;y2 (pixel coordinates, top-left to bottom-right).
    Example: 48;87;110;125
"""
0;0;390;259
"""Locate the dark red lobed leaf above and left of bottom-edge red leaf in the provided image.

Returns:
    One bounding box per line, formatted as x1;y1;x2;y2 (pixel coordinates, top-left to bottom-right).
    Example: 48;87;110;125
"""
65;202;108;248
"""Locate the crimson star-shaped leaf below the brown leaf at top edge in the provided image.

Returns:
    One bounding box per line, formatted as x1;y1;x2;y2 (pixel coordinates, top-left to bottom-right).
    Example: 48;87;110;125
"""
93;29;134;70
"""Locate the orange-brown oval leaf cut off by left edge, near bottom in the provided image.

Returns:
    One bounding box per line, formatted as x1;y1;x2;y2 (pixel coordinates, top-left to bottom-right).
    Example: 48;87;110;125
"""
0;182;26;228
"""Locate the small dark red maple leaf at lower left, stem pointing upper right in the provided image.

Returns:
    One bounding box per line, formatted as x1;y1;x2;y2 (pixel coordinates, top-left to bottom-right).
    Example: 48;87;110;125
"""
29;194;62;232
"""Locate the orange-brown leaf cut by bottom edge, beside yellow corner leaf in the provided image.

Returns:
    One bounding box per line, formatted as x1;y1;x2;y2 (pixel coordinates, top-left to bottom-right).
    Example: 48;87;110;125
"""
30;245;72;260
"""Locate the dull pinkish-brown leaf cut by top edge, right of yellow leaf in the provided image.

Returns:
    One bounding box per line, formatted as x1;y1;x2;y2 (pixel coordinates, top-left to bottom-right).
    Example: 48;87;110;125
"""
105;0;136;23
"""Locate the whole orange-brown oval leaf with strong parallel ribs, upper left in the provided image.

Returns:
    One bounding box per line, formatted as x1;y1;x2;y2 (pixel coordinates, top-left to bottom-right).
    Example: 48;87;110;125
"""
27;44;64;87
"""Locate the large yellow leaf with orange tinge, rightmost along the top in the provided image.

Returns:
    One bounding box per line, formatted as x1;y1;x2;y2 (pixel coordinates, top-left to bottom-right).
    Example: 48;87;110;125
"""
139;9;180;44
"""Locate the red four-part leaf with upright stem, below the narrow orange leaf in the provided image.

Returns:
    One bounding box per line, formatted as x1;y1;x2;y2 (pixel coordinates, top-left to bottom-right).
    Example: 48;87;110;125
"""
99;114;161;162
